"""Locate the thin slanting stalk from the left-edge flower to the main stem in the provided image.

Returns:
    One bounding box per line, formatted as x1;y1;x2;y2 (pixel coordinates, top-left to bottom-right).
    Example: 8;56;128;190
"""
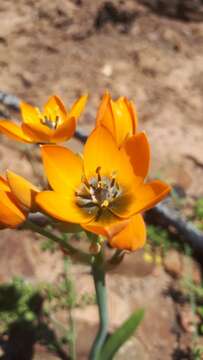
23;220;91;264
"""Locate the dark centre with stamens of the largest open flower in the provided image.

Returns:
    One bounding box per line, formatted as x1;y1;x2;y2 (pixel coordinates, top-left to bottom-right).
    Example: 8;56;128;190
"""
75;167;122;217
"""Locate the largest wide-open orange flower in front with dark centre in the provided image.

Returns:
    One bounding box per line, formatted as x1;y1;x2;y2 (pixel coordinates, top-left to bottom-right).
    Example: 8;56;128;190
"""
36;126;170;248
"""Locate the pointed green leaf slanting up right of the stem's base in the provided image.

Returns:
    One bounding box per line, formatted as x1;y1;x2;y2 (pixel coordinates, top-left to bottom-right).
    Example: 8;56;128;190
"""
98;309;144;360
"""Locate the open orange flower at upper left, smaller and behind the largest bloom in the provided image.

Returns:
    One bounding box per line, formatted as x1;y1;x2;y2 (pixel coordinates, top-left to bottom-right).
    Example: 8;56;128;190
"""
0;96;87;143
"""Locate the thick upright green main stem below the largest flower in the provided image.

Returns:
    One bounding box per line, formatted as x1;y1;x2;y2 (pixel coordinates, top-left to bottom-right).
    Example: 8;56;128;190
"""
89;251;108;360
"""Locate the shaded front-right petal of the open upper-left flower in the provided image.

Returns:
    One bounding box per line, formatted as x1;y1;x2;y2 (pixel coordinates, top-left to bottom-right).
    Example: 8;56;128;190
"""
51;117;76;143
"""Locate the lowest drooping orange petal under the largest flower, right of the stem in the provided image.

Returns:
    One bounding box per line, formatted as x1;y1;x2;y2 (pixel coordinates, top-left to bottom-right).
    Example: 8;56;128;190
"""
109;215;146;251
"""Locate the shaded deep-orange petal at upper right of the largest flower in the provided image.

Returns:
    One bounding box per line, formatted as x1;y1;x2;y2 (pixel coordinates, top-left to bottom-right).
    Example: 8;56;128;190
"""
123;132;150;184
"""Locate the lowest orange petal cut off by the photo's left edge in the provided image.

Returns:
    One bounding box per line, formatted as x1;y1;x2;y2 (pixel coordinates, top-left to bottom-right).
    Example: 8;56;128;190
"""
0;176;26;229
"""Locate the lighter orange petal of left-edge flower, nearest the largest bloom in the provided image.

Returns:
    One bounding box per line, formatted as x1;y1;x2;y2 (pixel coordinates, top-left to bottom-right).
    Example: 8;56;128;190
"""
7;171;39;211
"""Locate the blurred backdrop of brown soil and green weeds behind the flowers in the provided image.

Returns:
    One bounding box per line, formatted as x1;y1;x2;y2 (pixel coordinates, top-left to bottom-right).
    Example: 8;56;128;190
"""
0;0;203;360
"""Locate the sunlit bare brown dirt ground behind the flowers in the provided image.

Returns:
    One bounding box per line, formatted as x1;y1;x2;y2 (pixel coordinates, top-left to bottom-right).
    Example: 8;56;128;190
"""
0;0;203;360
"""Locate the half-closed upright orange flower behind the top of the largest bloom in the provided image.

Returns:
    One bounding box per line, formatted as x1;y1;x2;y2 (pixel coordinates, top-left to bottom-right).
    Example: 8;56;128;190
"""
96;92;138;146
